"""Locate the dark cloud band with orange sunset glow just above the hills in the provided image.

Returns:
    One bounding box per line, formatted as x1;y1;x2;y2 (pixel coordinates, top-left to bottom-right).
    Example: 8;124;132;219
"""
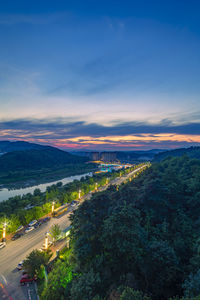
0;118;200;150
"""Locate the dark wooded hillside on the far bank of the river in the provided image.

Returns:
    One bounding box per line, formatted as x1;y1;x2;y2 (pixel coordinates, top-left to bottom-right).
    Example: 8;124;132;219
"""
0;147;93;184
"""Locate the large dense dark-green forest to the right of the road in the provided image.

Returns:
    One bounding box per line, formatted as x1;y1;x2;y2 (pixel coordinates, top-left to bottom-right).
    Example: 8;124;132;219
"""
41;157;200;300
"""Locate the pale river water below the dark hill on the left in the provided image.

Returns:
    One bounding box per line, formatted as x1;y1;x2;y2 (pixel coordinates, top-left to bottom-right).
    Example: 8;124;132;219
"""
0;173;92;202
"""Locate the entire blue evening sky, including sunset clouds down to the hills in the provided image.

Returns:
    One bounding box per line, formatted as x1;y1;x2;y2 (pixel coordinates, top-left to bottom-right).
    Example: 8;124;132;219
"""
0;0;200;150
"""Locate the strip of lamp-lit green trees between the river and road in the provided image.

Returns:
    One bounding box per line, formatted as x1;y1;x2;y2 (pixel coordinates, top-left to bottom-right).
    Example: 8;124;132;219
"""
0;166;137;238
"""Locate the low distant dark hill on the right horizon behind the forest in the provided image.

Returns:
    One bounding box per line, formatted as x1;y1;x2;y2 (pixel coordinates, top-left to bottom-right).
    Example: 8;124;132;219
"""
154;147;200;161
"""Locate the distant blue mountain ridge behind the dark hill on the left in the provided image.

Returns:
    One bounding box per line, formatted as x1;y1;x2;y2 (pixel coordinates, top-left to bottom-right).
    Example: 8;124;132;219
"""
0;141;48;153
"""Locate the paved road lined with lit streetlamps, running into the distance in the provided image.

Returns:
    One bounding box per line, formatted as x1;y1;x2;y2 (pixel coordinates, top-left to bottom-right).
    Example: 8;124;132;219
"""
0;165;146;300
